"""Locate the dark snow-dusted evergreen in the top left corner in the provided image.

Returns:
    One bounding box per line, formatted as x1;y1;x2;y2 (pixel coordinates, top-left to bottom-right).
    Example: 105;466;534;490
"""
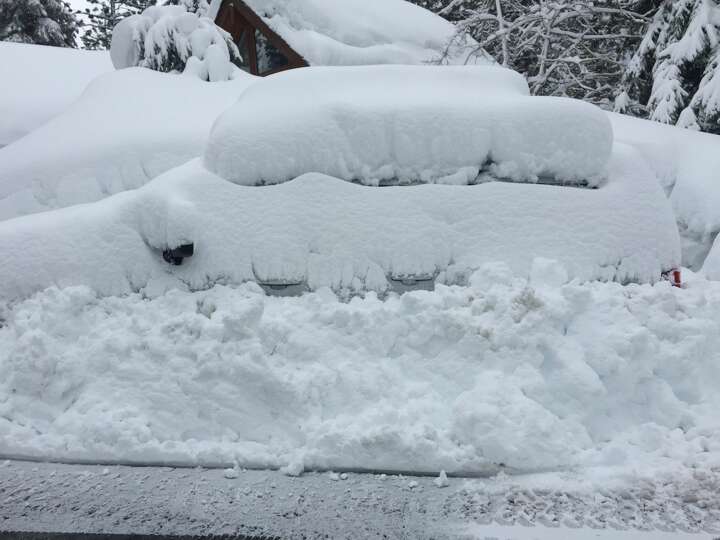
0;0;78;47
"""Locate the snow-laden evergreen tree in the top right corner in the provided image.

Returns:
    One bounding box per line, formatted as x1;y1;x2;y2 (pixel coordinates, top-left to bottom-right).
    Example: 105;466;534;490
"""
615;0;720;133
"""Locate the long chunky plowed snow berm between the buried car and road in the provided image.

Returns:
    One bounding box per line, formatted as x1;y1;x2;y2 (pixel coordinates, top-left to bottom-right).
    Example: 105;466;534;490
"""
0;266;720;474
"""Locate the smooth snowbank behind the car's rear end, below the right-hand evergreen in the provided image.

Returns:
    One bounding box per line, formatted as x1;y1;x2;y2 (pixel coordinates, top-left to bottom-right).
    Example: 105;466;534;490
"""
609;113;720;274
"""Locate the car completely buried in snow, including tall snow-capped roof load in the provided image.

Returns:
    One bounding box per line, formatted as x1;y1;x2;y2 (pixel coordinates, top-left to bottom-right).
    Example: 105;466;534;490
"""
0;66;680;297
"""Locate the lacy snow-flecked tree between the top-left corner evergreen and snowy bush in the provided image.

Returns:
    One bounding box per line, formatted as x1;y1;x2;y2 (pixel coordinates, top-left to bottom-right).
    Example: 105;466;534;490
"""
81;0;155;49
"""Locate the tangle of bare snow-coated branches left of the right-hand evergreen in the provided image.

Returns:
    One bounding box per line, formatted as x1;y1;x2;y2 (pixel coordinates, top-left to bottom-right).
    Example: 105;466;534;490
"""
418;0;646;107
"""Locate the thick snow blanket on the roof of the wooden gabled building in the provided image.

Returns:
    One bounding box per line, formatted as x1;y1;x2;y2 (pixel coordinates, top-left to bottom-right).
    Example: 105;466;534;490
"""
209;0;480;66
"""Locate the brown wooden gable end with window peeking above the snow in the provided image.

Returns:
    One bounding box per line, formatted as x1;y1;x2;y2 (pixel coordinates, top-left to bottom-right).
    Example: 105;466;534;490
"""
215;0;308;76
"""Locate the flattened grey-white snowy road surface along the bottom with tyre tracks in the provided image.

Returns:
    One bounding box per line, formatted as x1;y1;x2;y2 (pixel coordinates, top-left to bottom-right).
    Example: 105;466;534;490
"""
0;461;720;540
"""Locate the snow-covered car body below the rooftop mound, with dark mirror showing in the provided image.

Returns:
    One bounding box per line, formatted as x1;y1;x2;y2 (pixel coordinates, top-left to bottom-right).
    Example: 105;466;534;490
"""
0;143;680;299
